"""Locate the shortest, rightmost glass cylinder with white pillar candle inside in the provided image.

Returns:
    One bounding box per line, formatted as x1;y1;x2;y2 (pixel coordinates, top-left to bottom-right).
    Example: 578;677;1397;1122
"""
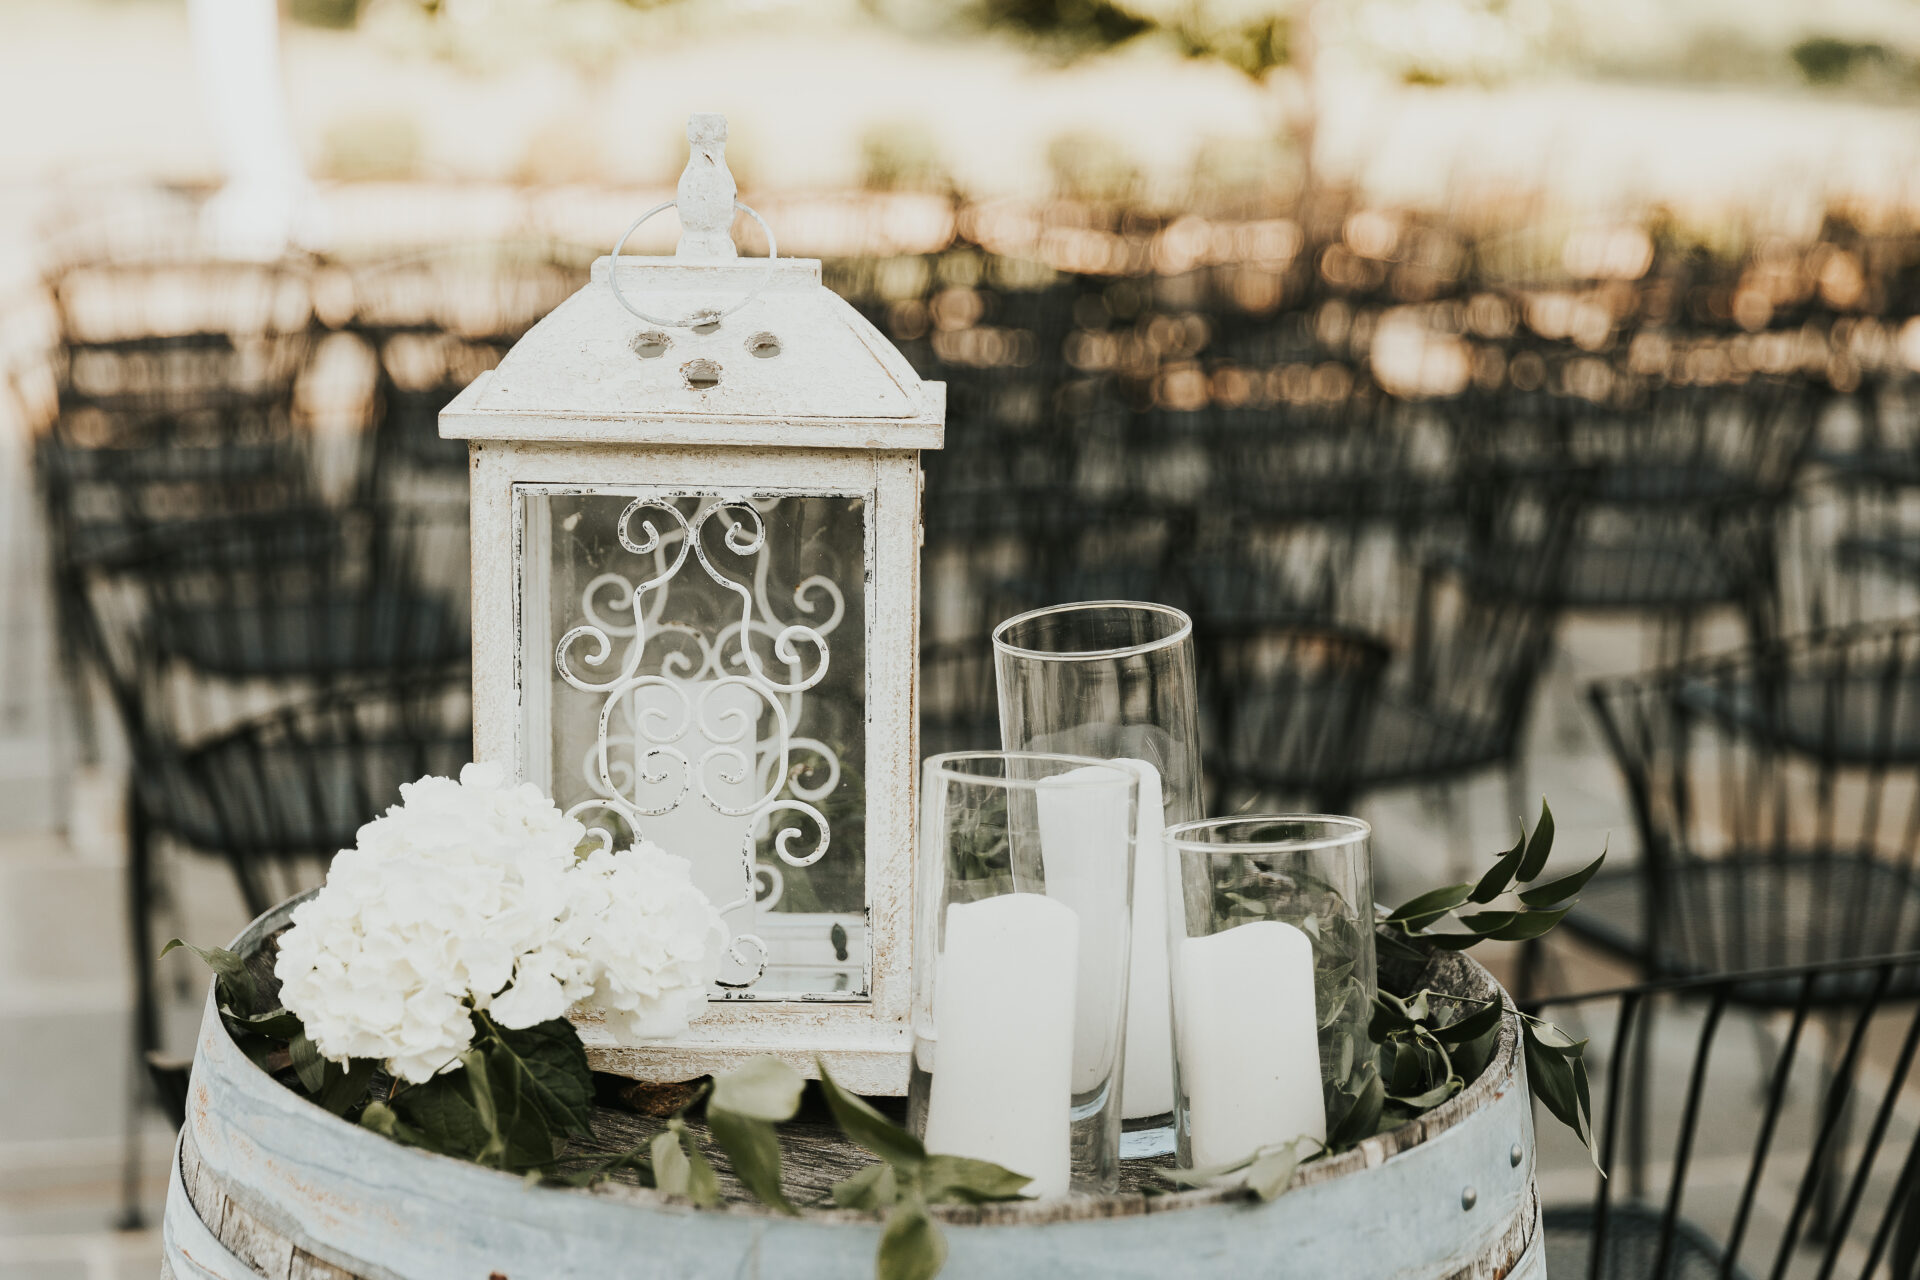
1165;816;1379;1169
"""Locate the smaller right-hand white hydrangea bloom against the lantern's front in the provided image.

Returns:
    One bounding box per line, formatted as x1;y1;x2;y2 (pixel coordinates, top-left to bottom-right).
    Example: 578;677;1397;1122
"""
574;841;728;1044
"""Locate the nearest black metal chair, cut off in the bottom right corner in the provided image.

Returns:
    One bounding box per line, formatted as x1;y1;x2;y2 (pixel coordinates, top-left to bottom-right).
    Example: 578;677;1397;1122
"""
1523;952;1920;1280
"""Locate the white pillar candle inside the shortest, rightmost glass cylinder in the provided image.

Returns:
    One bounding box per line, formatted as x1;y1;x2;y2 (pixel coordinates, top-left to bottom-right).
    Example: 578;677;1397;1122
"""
1175;919;1327;1169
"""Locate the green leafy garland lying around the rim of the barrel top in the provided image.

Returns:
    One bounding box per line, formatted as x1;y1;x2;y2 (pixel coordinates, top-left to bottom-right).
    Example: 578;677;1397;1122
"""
161;804;1605;1280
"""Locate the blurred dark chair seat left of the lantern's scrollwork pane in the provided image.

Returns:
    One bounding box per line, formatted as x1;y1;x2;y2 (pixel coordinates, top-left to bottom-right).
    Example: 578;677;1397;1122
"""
154;589;468;677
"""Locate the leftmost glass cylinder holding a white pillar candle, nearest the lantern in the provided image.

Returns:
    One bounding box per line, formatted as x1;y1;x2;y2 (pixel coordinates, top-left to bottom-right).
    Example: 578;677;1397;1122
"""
908;752;1128;1196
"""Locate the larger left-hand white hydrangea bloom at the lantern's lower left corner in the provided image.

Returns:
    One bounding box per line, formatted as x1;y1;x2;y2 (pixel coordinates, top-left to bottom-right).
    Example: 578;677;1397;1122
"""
275;764;591;1082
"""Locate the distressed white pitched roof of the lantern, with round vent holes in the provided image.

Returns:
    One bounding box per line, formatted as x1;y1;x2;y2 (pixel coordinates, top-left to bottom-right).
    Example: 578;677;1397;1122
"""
440;257;947;449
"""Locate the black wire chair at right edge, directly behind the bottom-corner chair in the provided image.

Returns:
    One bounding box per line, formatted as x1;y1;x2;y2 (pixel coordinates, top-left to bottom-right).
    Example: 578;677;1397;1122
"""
1567;622;1920;1006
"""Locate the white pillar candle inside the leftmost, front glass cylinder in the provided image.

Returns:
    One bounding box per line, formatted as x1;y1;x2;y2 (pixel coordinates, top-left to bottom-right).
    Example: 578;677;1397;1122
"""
925;892;1079;1196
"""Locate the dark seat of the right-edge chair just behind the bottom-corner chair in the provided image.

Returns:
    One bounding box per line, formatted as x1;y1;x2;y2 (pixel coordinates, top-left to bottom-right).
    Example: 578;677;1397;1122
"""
1563;852;1920;1007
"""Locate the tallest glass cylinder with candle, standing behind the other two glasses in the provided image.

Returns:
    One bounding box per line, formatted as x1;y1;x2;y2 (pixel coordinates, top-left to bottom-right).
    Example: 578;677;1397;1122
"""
993;601;1202;1159
